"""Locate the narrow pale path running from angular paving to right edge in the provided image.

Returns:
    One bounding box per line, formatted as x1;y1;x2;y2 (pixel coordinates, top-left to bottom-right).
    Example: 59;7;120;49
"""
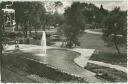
88;60;127;73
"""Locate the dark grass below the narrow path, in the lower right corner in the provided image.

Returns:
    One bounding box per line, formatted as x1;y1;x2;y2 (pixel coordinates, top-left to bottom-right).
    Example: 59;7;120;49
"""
85;63;127;83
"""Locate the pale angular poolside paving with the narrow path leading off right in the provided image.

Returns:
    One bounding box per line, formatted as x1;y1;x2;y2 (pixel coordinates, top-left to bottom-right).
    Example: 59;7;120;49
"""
73;48;127;73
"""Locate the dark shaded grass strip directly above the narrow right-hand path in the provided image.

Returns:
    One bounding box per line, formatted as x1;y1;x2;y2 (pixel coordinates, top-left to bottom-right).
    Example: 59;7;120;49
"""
90;52;127;67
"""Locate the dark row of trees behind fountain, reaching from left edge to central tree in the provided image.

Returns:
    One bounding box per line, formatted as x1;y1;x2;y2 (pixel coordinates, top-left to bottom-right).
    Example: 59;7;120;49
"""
1;2;63;37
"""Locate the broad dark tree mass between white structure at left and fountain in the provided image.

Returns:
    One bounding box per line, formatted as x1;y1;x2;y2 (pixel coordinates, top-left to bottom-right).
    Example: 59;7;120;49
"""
13;2;45;37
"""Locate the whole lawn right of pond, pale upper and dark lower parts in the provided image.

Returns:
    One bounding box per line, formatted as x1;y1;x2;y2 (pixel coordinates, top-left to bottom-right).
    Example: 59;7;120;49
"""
79;33;127;67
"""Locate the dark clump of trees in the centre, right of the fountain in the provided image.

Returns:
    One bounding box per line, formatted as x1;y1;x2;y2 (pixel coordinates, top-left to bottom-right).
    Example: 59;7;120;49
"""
61;2;109;47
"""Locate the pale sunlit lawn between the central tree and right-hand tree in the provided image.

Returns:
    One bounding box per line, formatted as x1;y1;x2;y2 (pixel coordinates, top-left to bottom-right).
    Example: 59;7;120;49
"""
79;33;127;53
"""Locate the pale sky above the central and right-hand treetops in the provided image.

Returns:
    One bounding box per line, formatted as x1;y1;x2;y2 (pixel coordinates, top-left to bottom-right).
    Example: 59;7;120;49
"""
55;0;127;13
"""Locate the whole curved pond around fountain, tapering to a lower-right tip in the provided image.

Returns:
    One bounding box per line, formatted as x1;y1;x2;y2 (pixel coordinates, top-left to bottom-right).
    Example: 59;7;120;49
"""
3;45;101;81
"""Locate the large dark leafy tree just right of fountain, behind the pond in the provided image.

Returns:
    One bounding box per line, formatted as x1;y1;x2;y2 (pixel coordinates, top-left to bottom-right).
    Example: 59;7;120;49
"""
63;2;85;47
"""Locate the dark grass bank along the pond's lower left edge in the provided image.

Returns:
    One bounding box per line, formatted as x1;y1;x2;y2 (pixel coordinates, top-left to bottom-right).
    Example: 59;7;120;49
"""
2;52;86;83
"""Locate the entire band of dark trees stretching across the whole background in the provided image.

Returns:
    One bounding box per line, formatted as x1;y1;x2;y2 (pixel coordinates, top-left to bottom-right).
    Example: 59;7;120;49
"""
0;1;127;53
